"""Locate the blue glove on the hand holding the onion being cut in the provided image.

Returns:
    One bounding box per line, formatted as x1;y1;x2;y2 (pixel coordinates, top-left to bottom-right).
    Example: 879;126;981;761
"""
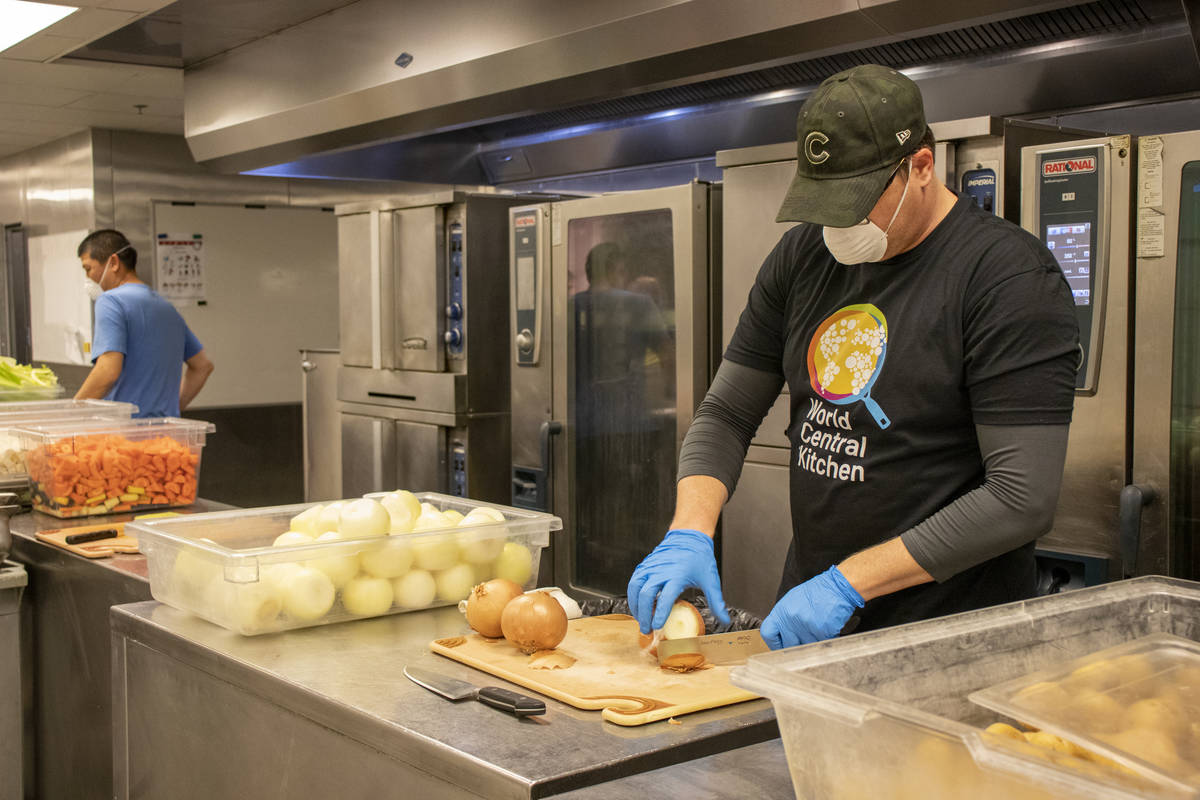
625;529;730;633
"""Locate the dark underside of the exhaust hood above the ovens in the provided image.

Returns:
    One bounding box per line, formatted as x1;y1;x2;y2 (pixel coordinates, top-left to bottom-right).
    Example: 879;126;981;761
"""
211;0;1185;184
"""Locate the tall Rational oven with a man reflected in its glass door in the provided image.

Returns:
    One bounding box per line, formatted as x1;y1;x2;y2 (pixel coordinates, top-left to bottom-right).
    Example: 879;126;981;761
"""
509;182;721;596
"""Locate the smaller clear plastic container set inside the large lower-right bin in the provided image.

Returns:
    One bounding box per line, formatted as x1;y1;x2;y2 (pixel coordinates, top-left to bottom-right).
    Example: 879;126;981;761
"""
970;633;1200;792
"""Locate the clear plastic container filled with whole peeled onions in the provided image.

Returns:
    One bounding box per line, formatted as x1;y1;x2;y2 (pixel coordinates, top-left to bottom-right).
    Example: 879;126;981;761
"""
126;492;563;636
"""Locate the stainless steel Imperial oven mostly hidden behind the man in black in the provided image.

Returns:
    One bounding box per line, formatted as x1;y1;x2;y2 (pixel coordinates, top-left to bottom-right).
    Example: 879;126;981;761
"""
716;116;1092;615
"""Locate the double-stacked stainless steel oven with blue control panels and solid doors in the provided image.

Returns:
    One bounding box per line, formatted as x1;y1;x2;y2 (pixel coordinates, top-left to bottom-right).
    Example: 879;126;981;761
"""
337;191;527;503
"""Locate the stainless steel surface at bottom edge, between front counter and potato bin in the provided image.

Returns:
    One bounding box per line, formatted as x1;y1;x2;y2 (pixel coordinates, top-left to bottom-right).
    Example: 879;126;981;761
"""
554;739;796;800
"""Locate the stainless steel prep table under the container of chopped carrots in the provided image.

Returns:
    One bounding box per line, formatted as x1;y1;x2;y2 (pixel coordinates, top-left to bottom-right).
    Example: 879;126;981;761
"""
10;499;230;800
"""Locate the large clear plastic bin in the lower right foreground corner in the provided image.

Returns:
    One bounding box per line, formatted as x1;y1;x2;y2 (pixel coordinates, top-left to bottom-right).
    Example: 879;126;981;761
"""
731;577;1200;800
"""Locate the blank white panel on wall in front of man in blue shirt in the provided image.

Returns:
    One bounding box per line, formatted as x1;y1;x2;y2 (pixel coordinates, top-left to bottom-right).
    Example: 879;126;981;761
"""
29;230;91;365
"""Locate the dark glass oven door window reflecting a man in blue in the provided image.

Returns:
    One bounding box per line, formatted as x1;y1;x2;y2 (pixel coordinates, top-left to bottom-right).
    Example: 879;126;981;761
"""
566;209;677;595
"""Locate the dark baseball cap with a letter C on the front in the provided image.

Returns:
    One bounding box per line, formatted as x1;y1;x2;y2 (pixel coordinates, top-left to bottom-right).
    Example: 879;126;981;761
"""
775;64;926;228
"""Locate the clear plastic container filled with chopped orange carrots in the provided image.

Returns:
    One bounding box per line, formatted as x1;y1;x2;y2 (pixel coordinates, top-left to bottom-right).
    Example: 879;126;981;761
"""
12;417;216;518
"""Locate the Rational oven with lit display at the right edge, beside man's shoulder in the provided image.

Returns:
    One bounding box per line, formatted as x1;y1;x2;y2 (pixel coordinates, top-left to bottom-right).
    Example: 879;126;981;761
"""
1022;132;1200;579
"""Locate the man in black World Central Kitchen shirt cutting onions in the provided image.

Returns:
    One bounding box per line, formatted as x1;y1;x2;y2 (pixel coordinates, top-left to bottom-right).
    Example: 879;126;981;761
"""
629;65;1079;648
